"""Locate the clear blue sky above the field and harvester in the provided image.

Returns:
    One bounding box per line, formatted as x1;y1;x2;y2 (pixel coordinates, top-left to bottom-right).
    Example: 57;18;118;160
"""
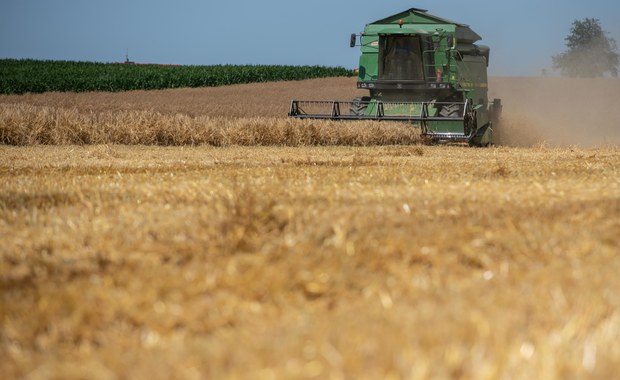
0;0;620;76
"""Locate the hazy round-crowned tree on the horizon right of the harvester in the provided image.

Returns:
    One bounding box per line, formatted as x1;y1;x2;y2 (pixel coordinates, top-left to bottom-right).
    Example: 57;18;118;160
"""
552;18;620;78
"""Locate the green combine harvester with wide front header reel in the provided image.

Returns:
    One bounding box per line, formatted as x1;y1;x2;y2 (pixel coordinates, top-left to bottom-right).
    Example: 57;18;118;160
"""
289;8;502;146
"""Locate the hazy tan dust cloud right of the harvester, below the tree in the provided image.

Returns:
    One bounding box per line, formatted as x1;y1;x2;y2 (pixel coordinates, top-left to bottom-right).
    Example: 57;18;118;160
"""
489;77;620;147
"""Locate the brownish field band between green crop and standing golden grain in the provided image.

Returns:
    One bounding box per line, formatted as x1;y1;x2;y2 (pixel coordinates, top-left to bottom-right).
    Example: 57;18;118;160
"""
0;78;367;119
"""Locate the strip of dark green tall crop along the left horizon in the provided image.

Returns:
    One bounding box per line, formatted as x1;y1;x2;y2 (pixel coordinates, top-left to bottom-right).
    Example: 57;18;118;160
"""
0;59;354;94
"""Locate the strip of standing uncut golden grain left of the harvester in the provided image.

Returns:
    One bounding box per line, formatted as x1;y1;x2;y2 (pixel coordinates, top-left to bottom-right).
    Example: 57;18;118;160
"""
0;103;420;146
